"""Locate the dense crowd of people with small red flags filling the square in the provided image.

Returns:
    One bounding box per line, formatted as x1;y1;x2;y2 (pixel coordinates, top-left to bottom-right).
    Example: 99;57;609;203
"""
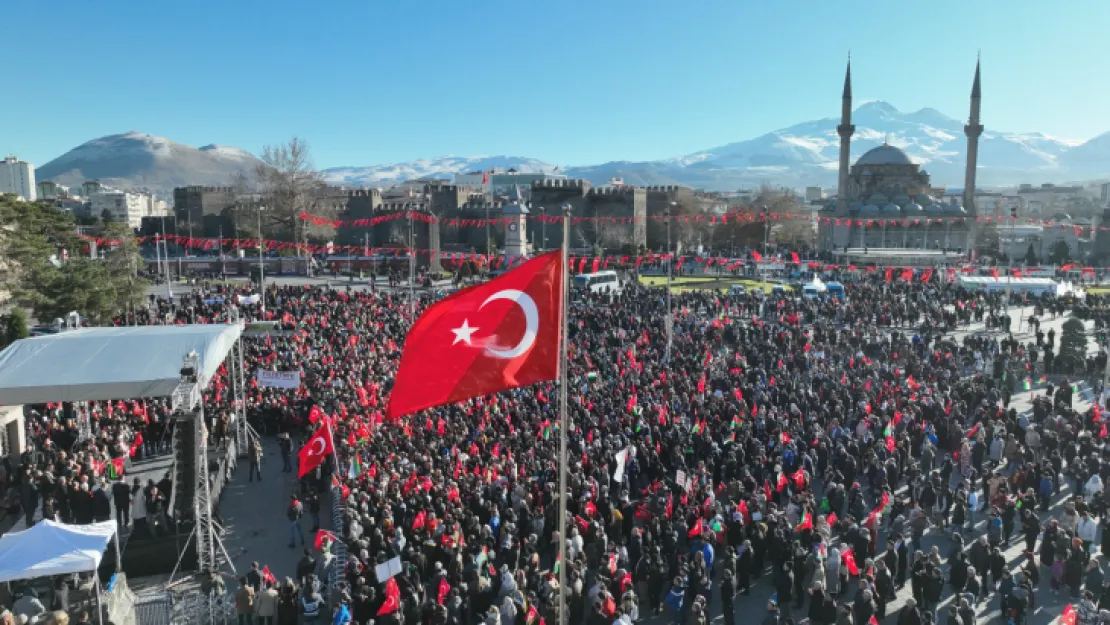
2;267;1110;625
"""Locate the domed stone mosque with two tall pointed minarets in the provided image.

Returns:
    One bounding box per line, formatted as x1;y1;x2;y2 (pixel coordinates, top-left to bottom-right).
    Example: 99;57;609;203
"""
818;60;983;256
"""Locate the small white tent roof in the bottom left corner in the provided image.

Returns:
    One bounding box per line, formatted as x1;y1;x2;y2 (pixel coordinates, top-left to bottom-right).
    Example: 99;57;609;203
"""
0;521;115;583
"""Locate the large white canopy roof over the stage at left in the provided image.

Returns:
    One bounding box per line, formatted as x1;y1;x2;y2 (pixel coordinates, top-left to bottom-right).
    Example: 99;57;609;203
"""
0;324;243;405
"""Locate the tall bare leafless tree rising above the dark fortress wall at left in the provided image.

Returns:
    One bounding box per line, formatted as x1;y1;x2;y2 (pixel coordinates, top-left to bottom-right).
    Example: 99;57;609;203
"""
257;137;324;236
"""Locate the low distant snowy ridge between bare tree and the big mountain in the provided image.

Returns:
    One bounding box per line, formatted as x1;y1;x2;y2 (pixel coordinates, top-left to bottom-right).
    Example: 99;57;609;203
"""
322;157;554;187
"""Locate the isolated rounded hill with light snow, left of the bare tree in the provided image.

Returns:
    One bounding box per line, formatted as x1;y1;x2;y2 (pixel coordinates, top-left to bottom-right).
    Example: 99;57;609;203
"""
36;132;259;194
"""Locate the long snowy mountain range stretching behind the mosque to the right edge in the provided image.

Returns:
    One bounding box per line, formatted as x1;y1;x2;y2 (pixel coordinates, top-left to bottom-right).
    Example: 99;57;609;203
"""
325;101;1110;190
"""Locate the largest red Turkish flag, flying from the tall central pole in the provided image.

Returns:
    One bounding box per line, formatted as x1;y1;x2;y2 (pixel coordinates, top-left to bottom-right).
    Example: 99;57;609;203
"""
385;252;566;419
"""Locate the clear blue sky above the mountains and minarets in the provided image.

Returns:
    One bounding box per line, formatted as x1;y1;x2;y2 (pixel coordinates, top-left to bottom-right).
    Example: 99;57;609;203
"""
8;0;1110;168
